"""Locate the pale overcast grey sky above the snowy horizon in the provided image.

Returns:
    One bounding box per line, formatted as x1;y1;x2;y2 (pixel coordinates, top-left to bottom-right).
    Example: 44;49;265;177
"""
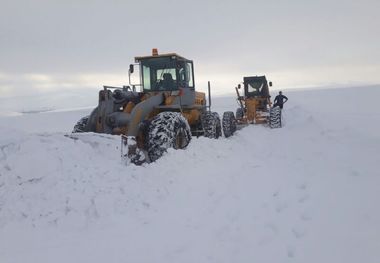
0;0;380;105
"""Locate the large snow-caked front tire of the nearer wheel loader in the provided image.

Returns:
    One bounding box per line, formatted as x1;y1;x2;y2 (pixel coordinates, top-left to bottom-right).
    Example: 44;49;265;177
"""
145;112;191;162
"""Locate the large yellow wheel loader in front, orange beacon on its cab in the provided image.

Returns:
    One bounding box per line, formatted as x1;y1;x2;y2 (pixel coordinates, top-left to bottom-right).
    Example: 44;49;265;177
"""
73;49;222;164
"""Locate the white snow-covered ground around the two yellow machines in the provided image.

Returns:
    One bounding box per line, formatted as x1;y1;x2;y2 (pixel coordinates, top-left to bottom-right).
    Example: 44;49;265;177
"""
0;87;380;263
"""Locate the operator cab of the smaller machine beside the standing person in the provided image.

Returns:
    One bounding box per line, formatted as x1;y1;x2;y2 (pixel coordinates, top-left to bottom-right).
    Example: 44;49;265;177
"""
244;76;272;98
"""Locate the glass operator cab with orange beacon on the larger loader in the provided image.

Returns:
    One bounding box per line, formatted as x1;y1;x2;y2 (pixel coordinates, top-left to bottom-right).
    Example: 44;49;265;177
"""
135;50;194;92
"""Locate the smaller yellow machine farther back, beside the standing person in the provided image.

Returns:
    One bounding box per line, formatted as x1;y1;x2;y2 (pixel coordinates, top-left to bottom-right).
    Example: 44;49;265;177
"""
222;76;281;137
